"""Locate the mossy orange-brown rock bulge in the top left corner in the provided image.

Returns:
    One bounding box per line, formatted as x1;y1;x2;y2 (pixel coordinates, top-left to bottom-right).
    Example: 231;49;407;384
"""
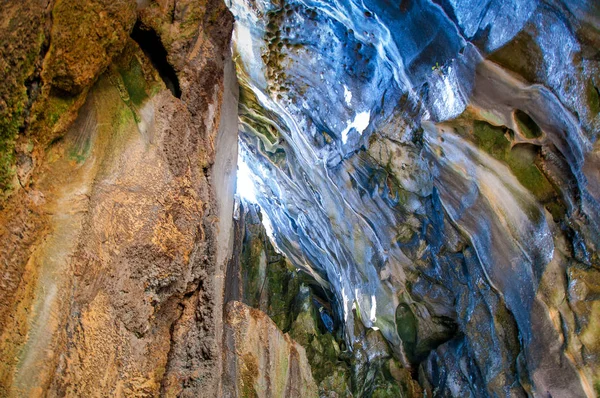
0;0;136;200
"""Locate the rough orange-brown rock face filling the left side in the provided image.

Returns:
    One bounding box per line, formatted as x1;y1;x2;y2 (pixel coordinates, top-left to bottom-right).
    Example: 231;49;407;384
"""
0;0;237;397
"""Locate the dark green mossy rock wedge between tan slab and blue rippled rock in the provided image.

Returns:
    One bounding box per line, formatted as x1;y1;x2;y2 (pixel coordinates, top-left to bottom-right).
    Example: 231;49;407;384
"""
225;201;420;397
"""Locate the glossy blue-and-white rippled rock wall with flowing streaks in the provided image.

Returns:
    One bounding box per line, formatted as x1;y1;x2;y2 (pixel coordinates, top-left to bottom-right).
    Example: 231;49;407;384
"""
228;0;600;397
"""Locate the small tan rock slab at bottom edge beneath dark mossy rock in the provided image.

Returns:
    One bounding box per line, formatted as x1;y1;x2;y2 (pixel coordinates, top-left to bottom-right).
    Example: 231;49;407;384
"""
223;301;318;398
